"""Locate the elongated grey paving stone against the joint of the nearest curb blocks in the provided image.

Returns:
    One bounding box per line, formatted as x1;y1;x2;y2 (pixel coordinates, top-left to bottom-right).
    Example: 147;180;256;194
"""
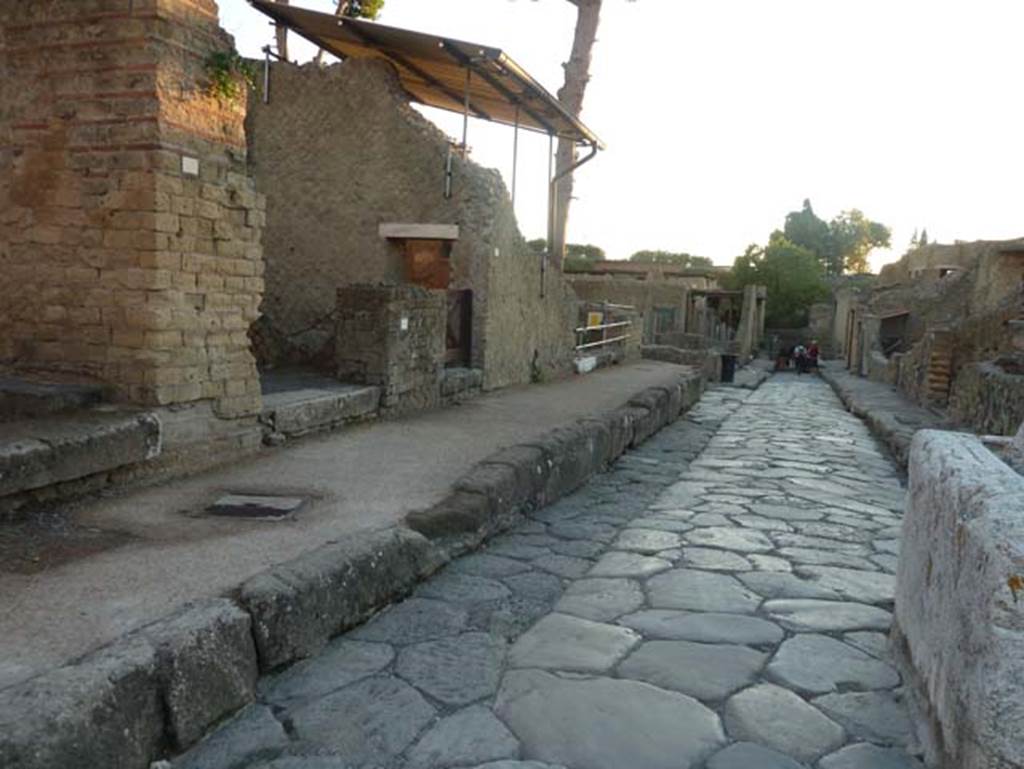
259;640;394;707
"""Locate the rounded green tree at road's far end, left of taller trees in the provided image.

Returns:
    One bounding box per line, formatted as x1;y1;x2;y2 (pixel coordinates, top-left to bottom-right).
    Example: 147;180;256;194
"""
724;230;828;329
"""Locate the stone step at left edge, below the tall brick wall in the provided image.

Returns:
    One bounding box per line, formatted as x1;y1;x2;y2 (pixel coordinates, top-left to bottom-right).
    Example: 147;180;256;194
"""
0;409;161;497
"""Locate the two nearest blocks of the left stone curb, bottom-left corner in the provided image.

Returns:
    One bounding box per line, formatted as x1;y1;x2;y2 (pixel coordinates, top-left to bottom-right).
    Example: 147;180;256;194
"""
0;599;257;769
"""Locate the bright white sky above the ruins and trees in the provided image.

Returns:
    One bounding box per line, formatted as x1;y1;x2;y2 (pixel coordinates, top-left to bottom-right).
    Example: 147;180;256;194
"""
219;0;1024;268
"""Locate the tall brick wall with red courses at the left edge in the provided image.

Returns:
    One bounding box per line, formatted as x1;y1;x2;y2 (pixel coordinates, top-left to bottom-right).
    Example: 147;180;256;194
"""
0;0;262;417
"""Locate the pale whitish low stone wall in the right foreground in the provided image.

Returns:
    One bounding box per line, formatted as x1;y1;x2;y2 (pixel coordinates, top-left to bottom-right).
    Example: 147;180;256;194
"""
892;430;1024;769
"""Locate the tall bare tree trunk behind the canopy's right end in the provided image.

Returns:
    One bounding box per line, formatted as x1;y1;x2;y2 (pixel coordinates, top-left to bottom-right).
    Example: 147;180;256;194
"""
550;0;601;269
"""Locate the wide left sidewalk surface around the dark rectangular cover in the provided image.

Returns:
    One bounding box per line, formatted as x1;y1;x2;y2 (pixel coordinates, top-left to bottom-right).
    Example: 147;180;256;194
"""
0;361;691;692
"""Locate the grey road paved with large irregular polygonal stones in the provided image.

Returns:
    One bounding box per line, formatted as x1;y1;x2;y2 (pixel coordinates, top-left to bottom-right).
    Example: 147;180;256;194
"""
174;375;920;769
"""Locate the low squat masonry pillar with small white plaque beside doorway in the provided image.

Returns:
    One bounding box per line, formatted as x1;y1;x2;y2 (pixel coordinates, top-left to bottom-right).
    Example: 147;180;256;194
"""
336;285;447;413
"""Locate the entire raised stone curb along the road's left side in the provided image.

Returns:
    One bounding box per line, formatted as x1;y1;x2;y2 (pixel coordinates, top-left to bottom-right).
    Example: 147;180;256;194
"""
0;372;705;769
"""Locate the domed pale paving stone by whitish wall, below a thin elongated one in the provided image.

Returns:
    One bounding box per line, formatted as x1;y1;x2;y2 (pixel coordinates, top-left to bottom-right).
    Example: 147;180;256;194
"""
767;634;900;694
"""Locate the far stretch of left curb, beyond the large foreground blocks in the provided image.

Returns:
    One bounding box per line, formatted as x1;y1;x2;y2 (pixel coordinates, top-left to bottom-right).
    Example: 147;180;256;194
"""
406;373;705;556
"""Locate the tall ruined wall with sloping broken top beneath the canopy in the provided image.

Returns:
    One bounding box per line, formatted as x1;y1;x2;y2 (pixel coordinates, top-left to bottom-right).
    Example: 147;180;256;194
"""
247;60;573;388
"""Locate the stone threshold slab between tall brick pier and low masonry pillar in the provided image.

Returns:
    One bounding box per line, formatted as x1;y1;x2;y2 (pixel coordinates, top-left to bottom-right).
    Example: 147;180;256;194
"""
260;382;381;442
